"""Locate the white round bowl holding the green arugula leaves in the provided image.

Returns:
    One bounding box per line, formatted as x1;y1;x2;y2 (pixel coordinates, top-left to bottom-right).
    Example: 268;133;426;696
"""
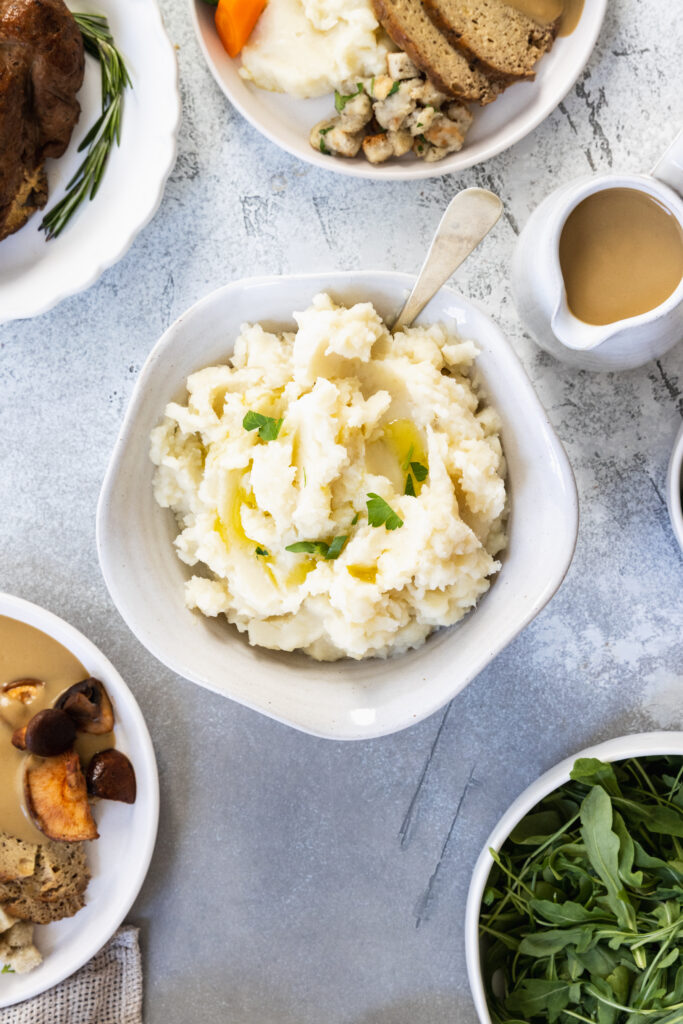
465;732;683;1024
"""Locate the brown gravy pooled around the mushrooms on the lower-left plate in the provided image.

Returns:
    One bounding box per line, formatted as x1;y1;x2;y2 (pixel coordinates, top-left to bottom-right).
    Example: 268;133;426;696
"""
0;615;115;843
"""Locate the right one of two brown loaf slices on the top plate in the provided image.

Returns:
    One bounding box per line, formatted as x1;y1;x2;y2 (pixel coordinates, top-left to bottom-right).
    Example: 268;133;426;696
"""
424;0;559;79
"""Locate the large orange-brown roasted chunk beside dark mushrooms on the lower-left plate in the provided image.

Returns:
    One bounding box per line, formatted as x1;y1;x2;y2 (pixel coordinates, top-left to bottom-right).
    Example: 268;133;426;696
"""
24;751;98;843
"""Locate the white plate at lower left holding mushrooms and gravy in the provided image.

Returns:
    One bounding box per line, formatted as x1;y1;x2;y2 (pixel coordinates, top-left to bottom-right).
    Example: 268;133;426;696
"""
0;594;159;1016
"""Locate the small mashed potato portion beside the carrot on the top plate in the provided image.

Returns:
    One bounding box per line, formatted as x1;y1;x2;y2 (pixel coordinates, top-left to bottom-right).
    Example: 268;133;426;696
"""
240;0;389;97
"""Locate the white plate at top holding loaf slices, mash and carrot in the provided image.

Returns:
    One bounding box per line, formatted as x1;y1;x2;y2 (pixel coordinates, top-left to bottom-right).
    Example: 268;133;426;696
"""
189;0;607;180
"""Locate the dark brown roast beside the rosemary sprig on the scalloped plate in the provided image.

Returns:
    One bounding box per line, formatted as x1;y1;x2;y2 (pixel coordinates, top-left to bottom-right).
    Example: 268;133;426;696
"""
0;0;85;241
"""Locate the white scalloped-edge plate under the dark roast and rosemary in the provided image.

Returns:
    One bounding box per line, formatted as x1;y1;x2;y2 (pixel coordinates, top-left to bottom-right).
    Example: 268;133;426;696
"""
0;0;180;324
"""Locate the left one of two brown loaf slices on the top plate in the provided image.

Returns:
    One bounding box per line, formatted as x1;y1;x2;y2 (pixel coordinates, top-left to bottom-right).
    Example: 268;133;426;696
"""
373;0;507;104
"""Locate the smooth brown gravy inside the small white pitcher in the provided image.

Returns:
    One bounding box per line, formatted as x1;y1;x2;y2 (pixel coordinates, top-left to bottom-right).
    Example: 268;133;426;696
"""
560;188;683;325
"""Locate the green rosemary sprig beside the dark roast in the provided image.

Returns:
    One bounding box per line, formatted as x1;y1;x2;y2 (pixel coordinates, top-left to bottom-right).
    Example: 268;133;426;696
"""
40;14;132;241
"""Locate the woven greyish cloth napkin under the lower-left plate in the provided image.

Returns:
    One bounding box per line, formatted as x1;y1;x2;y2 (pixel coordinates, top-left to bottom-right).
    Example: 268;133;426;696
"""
0;925;142;1024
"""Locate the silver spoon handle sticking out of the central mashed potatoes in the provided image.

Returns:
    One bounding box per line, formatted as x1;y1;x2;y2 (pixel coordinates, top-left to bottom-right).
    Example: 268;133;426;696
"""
391;188;503;331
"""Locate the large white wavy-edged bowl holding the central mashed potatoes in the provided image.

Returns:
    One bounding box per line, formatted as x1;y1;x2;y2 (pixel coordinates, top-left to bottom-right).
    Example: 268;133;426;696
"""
97;271;578;739
